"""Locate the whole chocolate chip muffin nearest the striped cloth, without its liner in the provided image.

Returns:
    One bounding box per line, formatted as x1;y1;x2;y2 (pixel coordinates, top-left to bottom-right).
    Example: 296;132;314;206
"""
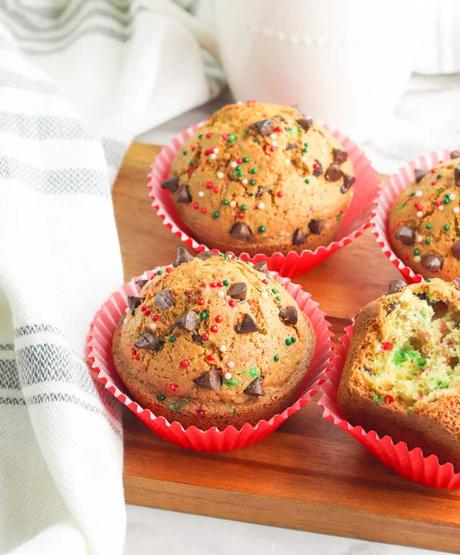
112;247;315;429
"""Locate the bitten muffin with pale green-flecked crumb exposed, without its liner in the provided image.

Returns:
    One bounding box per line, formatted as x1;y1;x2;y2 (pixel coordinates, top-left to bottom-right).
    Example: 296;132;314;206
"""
338;279;460;470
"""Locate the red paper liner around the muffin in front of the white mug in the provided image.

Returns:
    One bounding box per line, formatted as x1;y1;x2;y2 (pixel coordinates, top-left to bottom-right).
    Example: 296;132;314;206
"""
147;125;380;277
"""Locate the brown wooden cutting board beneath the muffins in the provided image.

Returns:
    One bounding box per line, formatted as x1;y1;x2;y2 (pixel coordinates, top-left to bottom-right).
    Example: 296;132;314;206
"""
113;144;460;553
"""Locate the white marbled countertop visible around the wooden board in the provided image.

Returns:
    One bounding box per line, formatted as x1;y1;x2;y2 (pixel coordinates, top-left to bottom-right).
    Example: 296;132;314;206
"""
125;75;460;555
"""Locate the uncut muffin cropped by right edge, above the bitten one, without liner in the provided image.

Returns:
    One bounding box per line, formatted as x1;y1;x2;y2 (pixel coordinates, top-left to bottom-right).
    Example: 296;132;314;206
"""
388;151;460;281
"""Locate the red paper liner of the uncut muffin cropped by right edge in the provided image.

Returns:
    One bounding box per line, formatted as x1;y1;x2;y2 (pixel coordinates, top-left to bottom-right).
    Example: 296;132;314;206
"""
371;150;458;283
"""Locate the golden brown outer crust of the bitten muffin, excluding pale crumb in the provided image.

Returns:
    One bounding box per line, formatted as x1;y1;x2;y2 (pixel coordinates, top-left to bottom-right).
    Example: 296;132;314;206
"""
337;280;460;468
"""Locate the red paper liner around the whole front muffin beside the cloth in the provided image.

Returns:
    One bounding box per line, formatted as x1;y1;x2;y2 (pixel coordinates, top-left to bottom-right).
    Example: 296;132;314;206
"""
87;269;332;452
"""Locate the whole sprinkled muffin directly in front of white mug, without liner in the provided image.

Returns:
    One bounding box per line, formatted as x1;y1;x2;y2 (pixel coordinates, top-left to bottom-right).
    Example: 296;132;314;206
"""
162;102;355;255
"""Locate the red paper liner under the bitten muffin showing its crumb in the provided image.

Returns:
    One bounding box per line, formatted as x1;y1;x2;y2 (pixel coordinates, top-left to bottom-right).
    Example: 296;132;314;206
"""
318;326;460;489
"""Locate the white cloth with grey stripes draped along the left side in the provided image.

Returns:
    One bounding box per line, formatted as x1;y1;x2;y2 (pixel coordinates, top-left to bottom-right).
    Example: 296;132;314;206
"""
0;0;223;555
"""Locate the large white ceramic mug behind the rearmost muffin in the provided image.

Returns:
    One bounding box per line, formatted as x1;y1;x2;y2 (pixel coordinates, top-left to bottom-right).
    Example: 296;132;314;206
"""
215;0;420;140
